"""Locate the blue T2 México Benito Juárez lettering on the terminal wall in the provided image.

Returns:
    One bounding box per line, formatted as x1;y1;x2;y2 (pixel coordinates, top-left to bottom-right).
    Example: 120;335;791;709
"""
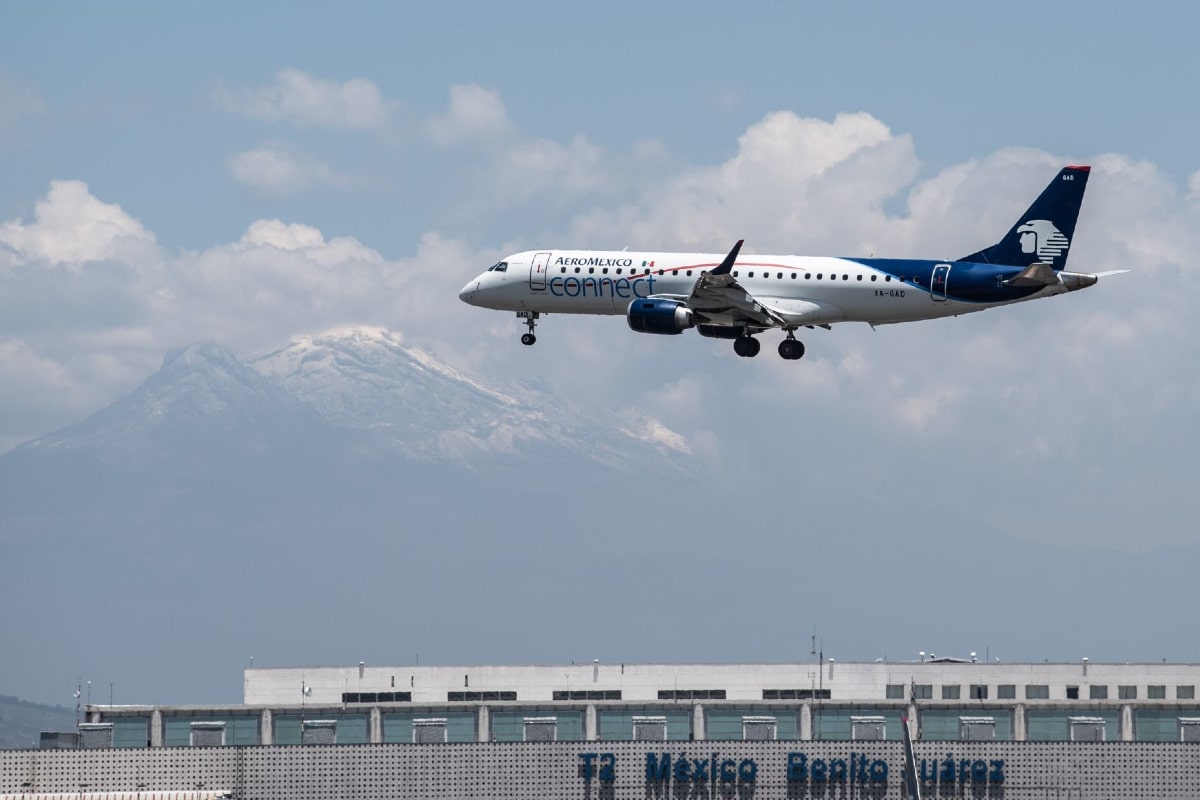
578;751;1004;786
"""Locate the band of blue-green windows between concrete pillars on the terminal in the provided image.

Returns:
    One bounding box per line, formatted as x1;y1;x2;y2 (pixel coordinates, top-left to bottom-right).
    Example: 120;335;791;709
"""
91;700;1200;748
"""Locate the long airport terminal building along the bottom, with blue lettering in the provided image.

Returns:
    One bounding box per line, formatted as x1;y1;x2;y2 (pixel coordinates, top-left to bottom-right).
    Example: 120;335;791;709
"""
0;656;1200;800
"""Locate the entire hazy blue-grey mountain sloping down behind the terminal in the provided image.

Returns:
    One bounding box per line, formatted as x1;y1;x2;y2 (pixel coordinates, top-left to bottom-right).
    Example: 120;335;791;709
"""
0;327;1200;703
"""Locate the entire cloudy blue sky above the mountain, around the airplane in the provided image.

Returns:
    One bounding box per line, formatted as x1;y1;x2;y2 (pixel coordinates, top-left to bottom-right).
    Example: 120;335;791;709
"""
0;2;1200;547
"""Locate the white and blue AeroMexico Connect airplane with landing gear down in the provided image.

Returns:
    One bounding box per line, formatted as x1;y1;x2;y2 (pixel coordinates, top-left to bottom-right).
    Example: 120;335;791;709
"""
458;166;1128;361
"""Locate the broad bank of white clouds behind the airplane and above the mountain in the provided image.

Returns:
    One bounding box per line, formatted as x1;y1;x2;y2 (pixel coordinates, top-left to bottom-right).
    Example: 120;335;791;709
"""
7;104;1200;551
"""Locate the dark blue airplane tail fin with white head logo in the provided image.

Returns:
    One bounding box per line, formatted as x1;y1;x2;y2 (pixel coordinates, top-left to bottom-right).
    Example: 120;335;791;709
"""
959;167;1092;270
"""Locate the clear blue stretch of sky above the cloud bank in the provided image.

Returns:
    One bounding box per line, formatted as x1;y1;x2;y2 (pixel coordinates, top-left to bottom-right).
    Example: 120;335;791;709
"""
0;2;1200;257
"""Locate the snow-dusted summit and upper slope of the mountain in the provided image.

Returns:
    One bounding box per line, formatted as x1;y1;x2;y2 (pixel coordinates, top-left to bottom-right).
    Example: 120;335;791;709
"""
248;327;688;465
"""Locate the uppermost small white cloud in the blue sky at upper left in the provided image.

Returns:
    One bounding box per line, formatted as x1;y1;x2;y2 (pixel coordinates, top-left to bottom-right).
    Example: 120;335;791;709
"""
214;70;388;131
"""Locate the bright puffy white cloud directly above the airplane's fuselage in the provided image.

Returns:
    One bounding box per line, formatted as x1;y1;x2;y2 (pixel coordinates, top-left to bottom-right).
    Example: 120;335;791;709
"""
575;112;918;253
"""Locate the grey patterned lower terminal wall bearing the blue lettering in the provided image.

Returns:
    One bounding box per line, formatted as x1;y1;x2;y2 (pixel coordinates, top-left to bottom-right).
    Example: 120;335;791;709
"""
0;741;1200;800
